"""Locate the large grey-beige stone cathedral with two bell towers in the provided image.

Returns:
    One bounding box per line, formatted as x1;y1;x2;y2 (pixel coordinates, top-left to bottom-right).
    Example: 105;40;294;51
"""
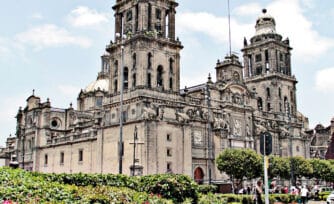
8;0;310;183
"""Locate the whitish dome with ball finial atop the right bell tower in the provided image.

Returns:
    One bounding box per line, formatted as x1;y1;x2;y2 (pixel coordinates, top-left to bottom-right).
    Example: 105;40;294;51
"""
255;9;276;35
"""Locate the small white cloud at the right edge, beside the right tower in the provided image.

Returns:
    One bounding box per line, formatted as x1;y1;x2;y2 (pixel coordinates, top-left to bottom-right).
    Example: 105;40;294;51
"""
315;67;334;93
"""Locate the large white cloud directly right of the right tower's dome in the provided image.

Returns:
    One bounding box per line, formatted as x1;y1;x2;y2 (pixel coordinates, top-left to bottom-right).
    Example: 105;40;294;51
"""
268;0;334;60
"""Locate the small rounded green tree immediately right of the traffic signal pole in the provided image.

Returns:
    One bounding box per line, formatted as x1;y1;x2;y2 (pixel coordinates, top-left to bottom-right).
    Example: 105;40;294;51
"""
268;156;290;179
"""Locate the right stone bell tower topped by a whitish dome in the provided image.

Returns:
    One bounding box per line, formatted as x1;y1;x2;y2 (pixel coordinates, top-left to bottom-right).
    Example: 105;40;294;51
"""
242;9;297;116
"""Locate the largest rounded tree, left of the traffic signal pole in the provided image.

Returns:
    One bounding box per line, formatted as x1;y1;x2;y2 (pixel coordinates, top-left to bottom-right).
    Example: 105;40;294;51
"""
216;149;263;190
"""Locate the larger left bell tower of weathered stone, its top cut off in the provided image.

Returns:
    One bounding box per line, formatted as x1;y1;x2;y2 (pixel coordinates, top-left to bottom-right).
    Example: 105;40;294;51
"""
106;0;183;94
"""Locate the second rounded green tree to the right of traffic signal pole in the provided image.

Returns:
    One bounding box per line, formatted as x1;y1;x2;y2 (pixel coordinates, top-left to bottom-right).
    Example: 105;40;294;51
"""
289;156;313;185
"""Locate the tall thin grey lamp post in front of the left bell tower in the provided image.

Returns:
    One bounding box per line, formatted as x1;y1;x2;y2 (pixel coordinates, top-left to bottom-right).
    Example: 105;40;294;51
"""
116;33;126;174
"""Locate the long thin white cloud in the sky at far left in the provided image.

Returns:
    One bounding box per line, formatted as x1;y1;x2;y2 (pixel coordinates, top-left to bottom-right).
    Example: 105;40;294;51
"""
16;24;91;50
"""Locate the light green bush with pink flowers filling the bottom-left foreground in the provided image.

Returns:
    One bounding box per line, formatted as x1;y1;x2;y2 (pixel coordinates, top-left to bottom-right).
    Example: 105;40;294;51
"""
0;168;172;204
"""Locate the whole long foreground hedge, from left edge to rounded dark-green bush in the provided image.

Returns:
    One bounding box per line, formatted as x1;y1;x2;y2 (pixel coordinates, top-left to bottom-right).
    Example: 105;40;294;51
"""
0;168;202;204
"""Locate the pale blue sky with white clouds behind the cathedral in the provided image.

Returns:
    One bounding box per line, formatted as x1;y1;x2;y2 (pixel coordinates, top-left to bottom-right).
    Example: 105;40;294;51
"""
0;0;334;146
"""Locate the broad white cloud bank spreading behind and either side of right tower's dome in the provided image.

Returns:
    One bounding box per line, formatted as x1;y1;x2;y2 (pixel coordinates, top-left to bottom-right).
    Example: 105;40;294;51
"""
177;0;334;60
